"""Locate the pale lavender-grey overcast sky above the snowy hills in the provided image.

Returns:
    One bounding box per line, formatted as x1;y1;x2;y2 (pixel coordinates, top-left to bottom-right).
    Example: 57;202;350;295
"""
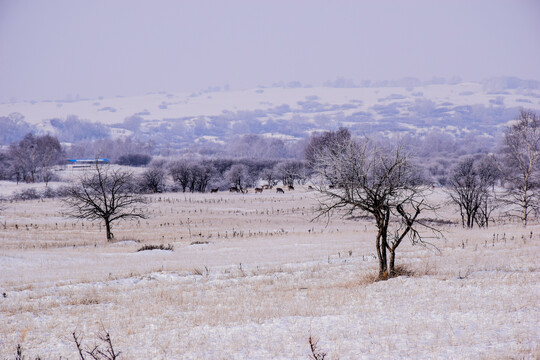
0;0;540;102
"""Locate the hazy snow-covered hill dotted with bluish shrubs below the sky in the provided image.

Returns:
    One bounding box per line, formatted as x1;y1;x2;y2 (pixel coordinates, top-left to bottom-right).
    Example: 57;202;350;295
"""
0;78;540;146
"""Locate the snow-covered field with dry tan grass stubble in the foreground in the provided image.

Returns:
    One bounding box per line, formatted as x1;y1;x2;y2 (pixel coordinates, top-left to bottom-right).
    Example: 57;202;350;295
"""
0;189;540;359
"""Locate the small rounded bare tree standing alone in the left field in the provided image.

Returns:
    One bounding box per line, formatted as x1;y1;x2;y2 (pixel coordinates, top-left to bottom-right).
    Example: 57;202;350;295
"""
63;162;146;241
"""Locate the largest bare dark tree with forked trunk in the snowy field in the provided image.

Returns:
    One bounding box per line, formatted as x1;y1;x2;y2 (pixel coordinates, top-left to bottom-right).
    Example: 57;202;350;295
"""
313;139;440;279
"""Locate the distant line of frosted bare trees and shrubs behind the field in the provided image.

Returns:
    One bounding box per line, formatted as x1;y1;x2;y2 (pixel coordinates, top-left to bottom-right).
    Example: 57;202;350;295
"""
4;110;540;228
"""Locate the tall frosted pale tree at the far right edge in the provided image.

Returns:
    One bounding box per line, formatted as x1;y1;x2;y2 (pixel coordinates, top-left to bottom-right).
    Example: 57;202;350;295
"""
502;110;540;226
